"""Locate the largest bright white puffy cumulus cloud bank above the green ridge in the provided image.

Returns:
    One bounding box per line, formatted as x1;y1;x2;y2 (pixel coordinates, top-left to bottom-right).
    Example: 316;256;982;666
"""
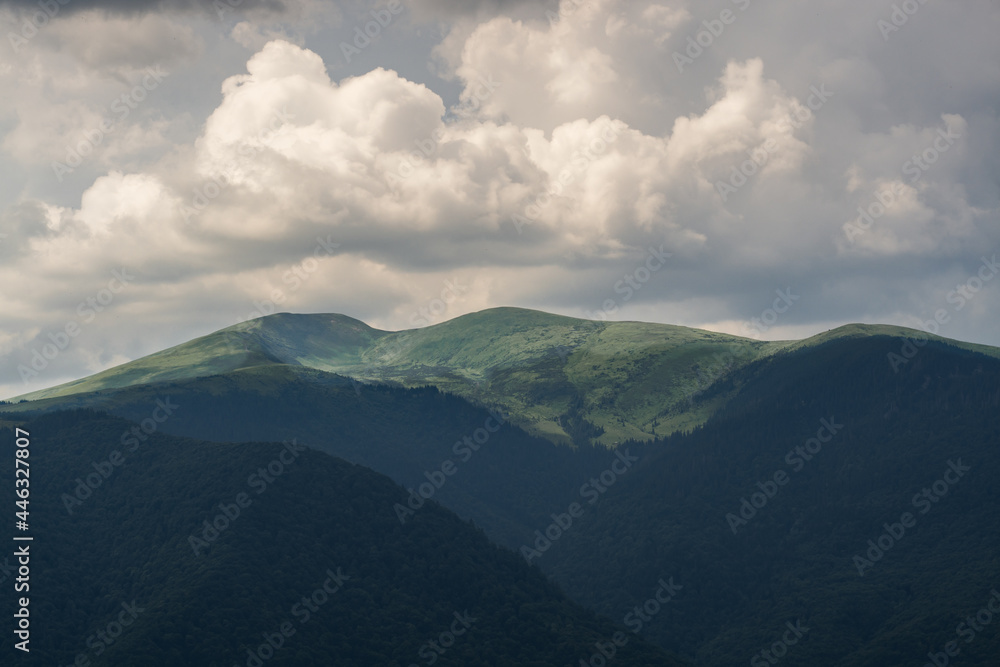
0;41;860;318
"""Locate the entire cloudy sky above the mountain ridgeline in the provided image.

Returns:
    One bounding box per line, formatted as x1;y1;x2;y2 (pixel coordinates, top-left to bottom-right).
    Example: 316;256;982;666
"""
0;0;1000;398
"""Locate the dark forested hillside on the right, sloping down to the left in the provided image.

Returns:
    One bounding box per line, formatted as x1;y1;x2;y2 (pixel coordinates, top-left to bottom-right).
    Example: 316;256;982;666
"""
541;338;1000;667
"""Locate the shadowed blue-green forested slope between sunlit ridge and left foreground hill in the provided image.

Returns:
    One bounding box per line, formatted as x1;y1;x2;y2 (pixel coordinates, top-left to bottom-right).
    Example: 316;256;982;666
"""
7;367;644;548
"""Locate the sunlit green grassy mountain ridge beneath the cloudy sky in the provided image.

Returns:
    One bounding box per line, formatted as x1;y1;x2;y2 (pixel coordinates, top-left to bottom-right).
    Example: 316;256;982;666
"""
14;308;1000;445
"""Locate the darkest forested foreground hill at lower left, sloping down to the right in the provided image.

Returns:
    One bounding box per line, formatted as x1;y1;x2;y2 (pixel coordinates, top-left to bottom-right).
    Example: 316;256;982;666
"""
0;411;683;667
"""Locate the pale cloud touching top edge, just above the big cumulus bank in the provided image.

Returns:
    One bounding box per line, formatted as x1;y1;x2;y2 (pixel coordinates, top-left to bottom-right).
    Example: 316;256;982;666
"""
446;0;690;131
